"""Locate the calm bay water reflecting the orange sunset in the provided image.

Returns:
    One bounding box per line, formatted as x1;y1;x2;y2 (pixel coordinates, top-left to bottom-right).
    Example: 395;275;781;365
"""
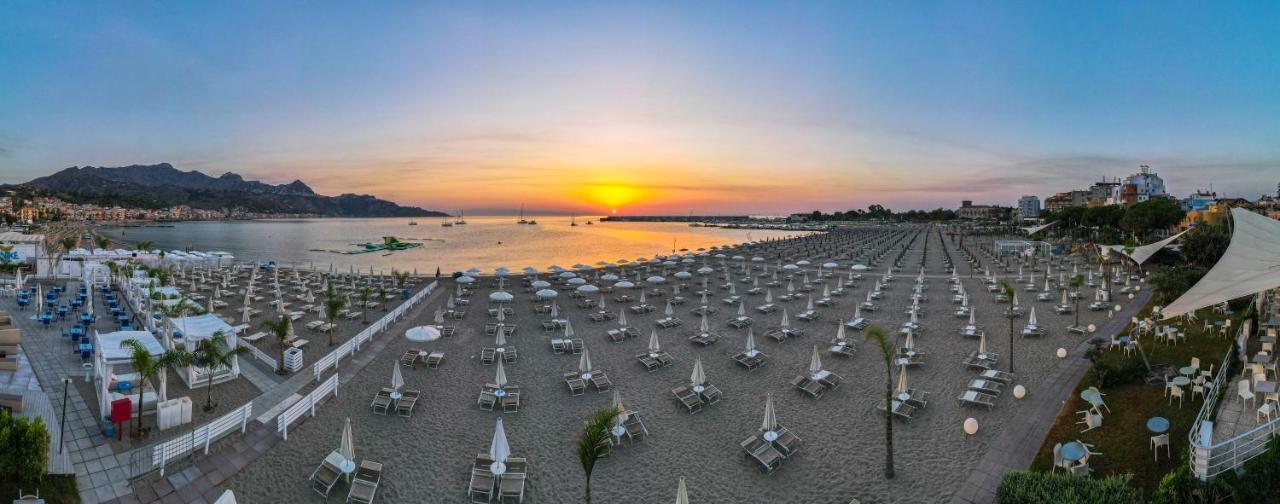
100;216;797;274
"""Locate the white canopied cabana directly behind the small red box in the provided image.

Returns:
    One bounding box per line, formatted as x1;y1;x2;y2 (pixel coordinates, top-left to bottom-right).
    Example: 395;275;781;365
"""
93;331;168;418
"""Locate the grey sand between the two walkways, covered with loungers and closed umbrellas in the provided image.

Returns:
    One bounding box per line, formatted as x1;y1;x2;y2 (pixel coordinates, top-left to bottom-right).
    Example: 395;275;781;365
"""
222;228;1121;503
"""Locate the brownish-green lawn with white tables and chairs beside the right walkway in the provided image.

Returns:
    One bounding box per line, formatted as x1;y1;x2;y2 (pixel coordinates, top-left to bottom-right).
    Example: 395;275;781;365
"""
1030;306;1239;496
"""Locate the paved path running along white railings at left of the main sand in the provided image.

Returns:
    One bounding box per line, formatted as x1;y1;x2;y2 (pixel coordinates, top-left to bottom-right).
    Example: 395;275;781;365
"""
106;280;448;503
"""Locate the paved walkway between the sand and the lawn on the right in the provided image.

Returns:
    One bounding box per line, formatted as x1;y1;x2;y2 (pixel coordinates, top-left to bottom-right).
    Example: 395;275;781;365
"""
951;289;1151;504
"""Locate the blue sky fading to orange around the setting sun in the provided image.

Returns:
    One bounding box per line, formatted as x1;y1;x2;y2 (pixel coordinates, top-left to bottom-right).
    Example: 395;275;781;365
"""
0;0;1280;215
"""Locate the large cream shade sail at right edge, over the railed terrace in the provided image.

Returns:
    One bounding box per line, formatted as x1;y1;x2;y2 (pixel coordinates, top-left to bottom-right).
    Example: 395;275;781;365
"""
1160;209;1280;319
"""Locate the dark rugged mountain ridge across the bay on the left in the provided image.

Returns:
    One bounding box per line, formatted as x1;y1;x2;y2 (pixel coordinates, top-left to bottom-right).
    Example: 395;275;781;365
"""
12;162;445;217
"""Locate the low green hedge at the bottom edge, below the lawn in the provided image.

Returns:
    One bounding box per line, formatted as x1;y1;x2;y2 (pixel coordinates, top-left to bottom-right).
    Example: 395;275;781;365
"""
996;471;1139;504
